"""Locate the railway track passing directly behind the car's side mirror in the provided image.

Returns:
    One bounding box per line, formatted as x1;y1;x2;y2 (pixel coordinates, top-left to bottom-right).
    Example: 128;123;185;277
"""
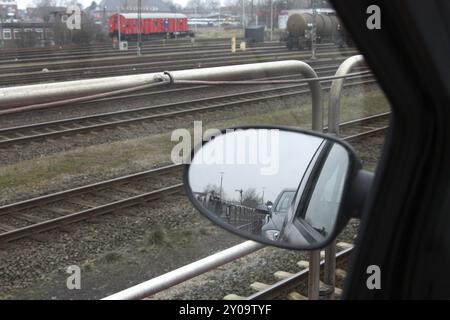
0;113;389;244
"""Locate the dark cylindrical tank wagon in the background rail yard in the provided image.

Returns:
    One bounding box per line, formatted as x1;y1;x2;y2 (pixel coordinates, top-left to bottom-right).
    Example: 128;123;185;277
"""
285;12;352;50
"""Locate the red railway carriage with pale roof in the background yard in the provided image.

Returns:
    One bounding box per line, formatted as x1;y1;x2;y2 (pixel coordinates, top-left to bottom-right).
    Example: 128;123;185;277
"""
108;13;194;41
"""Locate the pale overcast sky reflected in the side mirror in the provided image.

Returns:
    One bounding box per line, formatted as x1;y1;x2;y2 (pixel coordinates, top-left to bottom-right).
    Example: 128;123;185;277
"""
189;131;323;202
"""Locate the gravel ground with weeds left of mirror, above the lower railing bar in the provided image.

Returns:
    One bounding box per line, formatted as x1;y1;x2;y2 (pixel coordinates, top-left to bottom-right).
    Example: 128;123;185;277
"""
0;196;241;299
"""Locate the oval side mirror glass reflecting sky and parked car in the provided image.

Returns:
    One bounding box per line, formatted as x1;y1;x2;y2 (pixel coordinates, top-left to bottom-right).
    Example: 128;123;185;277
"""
186;129;350;249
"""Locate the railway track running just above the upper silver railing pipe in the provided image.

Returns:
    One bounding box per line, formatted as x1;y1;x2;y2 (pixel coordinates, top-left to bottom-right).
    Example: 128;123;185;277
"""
0;49;356;86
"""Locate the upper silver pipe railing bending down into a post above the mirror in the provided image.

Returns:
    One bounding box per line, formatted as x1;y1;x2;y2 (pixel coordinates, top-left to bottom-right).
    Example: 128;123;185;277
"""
0;60;322;127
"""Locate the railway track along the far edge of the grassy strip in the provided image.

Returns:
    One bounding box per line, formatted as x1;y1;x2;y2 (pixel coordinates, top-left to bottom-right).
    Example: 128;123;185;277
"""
0;70;375;147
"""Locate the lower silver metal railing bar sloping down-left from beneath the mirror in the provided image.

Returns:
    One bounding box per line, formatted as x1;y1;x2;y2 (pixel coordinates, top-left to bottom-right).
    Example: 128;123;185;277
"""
103;241;264;300
